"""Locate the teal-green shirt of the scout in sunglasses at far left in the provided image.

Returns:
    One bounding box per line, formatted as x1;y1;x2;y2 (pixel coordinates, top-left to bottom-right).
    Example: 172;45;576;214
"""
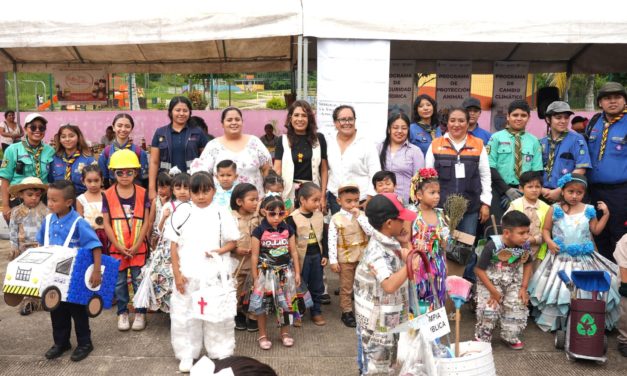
0;142;54;185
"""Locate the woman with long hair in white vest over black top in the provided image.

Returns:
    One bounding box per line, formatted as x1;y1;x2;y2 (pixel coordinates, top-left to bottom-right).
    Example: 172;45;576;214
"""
274;100;329;208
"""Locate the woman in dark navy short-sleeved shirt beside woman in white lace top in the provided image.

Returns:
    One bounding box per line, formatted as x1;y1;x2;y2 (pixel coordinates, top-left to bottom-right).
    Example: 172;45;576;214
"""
148;97;209;200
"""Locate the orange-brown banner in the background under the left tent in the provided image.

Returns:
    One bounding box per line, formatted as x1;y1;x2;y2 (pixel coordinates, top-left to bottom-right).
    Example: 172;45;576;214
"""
54;69;108;104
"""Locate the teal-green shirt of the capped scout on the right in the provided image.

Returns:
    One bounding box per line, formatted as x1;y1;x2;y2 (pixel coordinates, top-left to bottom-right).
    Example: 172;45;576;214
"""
488;129;543;186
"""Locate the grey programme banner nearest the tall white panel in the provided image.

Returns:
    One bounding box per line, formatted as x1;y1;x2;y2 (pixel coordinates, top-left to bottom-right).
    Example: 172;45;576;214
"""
388;60;416;118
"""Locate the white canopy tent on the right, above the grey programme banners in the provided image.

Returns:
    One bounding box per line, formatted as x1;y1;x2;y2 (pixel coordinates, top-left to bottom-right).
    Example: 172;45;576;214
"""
302;0;627;73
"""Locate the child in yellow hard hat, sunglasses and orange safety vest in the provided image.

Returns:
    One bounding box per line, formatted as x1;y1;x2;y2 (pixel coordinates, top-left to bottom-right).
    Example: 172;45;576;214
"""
102;149;150;331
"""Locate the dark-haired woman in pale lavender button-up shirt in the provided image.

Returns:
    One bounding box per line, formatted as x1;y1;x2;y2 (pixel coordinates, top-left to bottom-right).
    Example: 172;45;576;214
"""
378;112;425;203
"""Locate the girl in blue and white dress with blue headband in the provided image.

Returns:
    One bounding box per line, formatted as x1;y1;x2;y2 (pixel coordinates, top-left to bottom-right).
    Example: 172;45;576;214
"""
529;174;620;331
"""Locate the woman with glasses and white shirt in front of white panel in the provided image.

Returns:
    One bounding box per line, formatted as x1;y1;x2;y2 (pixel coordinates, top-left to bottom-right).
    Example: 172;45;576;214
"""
327;105;381;214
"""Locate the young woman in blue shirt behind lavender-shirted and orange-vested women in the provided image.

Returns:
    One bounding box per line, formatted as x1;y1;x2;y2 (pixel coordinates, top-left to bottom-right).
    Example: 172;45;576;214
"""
409;94;442;155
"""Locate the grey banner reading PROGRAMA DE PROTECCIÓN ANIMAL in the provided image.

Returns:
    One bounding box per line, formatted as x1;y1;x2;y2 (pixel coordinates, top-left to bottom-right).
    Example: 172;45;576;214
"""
435;60;472;109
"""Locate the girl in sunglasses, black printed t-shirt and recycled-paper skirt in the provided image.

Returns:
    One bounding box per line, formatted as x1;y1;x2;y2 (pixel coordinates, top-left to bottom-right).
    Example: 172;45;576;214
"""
248;193;300;350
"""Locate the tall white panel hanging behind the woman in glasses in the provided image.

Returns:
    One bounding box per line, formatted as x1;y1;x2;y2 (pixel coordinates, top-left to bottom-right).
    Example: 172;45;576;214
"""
316;39;390;142
